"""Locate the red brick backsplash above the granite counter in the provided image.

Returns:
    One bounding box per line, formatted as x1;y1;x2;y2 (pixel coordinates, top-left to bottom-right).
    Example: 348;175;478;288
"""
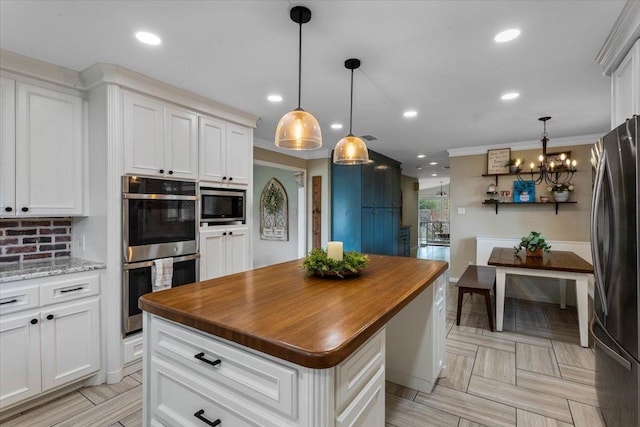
0;218;71;263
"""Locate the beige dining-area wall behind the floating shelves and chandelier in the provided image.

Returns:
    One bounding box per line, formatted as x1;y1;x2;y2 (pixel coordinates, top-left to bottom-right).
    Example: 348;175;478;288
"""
450;140;595;292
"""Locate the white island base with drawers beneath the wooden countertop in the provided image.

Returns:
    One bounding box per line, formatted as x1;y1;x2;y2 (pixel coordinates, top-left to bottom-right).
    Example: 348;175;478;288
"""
143;313;385;427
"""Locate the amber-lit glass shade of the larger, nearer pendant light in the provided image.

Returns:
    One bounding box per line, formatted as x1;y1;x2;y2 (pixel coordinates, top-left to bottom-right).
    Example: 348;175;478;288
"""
275;109;322;150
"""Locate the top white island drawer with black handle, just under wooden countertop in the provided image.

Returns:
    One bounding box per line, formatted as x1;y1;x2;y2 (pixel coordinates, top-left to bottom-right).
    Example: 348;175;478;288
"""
151;318;299;418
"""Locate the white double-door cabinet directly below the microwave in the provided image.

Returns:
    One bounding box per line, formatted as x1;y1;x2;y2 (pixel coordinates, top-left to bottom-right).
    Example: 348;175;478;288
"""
200;226;251;280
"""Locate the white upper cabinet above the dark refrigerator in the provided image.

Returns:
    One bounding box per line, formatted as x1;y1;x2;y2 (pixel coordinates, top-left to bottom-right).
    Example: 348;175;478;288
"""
611;39;640;129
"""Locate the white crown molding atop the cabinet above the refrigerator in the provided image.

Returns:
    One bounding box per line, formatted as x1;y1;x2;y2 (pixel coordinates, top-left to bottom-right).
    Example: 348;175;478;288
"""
596;0;640;76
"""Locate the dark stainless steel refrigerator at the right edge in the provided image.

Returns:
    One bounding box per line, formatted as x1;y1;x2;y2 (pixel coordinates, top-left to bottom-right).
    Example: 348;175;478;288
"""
591;115;640;427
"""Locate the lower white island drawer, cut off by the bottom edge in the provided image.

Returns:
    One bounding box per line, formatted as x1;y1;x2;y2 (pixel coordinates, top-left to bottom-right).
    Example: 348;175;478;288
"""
150;361;261;427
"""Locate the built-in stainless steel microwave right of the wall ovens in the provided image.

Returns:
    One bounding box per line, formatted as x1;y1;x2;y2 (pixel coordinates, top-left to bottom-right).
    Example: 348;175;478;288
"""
200;187;247;224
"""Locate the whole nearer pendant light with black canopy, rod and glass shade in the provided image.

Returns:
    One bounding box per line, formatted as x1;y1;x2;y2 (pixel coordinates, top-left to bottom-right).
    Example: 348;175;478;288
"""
275;6;322;150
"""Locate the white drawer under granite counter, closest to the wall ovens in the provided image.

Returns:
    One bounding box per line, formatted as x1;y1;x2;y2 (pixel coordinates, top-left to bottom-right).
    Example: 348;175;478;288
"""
40;273;100;305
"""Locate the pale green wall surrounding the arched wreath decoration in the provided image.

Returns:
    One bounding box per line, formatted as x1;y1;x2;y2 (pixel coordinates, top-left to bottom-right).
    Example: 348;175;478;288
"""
252;165;298;268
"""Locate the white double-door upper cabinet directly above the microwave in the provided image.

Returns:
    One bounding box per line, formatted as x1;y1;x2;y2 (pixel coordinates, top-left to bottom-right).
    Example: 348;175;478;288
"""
199;117;253;185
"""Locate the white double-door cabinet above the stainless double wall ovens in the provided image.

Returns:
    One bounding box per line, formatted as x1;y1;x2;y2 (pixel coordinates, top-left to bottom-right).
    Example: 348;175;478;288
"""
122;92;198;179
